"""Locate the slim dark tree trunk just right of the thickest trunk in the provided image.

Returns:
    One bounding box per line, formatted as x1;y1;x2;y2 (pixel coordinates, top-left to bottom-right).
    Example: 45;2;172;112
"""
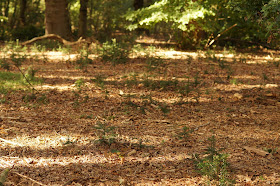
78;0;88;38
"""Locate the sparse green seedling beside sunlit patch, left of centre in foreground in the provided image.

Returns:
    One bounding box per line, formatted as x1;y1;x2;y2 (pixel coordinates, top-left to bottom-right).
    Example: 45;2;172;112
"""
94;121;117;145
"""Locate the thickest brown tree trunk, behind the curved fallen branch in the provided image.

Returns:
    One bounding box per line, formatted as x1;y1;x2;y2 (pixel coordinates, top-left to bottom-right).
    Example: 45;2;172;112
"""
45;0;72;40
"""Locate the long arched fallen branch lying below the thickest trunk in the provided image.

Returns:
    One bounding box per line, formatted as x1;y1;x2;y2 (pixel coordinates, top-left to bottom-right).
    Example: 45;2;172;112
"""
21;34;89;46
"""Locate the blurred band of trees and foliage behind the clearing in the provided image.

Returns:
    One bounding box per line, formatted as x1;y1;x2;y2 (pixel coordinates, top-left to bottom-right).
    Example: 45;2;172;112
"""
0;0;280;49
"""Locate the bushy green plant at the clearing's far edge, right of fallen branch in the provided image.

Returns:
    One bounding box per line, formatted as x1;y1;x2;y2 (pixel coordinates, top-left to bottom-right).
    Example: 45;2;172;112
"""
99;39;130;65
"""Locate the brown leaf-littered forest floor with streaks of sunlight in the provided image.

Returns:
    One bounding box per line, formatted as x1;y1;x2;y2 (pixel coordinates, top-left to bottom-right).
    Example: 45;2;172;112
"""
0;39;280;186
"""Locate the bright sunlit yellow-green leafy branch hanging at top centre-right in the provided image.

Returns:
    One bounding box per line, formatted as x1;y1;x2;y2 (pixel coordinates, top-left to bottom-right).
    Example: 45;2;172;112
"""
126;0;210;31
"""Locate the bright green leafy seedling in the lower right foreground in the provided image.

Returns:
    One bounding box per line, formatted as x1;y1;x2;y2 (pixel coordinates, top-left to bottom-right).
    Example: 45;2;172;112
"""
194;135;234;185
